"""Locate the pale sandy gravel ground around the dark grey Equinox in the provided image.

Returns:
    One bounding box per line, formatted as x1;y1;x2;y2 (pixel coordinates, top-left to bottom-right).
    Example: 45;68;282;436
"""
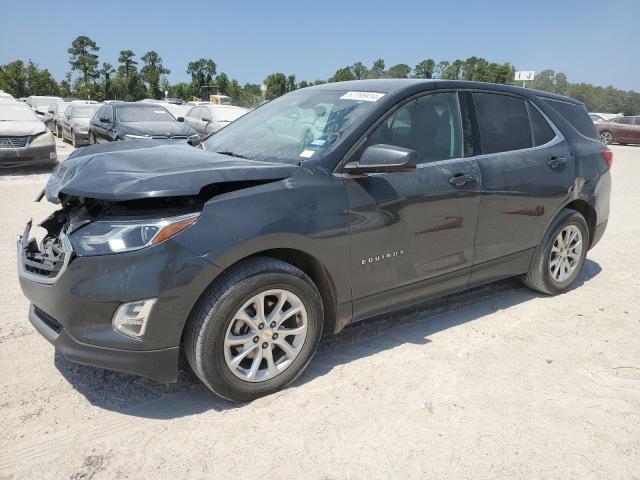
0;141;640;479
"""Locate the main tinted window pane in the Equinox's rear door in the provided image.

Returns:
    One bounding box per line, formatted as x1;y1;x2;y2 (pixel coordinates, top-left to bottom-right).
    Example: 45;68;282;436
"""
473;93;533;154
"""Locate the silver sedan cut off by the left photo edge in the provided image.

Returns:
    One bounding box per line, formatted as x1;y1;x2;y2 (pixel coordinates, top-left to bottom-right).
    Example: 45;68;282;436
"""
0;100;58;167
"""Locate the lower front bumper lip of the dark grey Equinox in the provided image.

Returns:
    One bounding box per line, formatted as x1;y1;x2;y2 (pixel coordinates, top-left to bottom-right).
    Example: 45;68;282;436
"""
29;305;179;383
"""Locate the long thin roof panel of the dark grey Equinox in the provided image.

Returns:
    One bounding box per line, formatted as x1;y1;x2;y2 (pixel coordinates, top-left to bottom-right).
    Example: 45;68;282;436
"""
309;78;581;104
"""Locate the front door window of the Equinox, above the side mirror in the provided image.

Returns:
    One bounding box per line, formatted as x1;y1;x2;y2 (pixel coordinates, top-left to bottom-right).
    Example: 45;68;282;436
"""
365;92;462;163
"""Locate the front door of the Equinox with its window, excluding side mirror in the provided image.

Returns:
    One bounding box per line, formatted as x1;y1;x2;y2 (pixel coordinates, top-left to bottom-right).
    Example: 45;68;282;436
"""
345;92;480;319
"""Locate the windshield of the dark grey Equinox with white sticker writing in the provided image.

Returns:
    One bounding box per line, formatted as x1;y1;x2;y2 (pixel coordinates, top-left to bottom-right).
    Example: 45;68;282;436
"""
202;89;384;162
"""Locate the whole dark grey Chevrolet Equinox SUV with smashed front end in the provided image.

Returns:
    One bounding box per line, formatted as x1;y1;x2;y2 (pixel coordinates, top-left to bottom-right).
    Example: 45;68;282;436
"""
17;80;612;401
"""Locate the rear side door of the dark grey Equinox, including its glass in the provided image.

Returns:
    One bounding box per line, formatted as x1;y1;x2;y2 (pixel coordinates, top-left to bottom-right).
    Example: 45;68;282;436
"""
471;92;575;283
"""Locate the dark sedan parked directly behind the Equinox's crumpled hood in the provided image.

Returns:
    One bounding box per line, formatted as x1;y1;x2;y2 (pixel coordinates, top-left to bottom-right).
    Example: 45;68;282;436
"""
89;102;198;144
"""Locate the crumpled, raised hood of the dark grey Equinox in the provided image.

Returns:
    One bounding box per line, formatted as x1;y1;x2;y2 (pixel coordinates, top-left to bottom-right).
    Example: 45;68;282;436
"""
45;140;300;203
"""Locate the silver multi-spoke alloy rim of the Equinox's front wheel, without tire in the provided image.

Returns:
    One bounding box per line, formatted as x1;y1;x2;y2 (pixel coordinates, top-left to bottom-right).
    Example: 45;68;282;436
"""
224;289;307;382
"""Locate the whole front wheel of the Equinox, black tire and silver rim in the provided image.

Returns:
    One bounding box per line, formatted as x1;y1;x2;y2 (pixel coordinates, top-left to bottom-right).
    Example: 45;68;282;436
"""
184;258;324;401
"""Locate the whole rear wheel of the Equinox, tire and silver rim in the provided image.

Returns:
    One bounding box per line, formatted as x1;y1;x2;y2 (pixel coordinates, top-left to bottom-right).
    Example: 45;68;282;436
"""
524;208;590;295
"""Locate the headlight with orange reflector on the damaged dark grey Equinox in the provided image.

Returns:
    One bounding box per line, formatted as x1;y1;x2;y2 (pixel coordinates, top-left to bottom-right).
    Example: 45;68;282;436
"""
69;213;200;257
